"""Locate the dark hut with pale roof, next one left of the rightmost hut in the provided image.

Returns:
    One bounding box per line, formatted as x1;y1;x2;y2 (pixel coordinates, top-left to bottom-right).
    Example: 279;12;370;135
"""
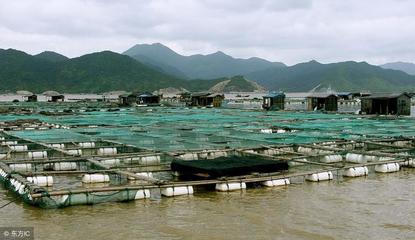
307;93;338;111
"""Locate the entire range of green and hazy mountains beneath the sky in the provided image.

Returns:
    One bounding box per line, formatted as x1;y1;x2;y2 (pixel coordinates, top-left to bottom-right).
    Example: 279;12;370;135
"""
0;44;415;93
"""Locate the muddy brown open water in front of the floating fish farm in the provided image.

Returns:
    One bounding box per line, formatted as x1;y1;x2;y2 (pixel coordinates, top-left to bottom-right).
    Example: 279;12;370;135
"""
0;169;415;240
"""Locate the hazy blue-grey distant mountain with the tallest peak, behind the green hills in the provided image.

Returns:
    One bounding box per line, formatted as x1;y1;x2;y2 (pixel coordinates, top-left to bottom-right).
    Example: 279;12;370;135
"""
124;43;285;79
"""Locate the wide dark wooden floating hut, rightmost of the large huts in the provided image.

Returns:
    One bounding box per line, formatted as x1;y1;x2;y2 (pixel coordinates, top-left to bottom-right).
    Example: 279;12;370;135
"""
361;93;411;115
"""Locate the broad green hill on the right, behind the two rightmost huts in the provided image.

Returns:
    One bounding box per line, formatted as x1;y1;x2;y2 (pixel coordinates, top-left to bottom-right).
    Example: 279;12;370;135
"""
246;61;415;92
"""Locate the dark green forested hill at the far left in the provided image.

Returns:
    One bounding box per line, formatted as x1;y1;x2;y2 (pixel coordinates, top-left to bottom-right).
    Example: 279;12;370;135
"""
0;49;192;92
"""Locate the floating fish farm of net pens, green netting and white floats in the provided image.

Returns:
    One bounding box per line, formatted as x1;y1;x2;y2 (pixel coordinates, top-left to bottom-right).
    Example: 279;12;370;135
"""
0;103;415;208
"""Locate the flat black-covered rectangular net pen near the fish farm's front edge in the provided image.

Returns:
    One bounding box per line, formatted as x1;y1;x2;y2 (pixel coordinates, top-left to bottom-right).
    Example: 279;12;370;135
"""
171;156;288;178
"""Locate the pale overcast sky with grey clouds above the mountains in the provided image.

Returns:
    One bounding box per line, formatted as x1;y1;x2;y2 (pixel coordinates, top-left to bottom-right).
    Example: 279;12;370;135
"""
0;0;415;65
